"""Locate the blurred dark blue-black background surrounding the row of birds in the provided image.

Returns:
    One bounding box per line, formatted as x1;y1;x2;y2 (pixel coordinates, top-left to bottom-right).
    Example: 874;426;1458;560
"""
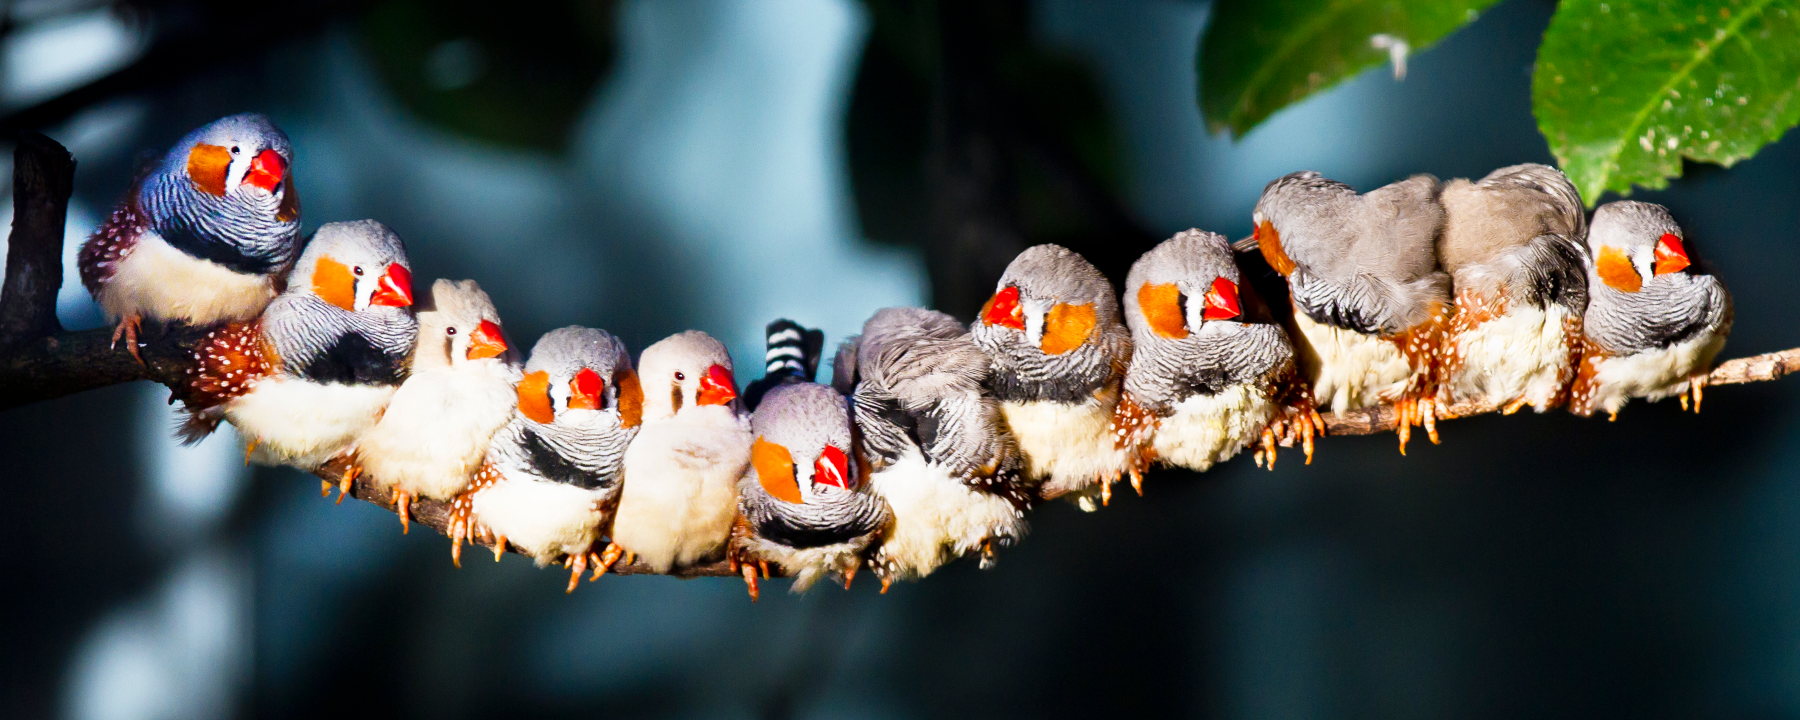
0;0;1800;720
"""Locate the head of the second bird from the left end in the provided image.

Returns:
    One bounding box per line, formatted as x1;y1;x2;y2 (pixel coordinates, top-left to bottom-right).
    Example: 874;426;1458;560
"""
298;220;412;315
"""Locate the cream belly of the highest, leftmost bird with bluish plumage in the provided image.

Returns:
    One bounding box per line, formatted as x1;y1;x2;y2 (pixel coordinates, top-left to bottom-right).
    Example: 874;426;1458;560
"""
97;232;275;326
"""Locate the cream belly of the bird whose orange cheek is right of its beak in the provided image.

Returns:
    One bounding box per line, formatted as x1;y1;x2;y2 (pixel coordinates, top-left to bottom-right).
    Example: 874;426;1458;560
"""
1001;398;1129;495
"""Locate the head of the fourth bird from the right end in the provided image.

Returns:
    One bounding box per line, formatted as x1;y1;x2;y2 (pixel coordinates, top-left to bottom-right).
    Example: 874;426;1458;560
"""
1125;230;1244;346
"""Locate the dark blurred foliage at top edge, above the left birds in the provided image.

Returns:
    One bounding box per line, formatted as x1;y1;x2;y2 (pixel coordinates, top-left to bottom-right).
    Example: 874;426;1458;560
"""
360;0;617;151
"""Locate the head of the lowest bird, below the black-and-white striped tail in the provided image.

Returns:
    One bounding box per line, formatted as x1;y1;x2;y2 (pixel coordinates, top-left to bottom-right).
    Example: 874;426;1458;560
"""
751;383;862;504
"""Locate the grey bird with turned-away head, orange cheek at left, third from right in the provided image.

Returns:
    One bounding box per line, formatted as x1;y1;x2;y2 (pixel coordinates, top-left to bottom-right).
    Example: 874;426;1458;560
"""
1253;171;1451;454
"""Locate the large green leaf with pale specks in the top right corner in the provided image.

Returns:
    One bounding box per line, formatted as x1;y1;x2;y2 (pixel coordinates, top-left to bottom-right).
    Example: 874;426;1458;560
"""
1532;0;1800;207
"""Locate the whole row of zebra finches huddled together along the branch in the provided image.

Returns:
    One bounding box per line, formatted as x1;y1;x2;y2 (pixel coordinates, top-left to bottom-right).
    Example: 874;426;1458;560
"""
79;113;1732;599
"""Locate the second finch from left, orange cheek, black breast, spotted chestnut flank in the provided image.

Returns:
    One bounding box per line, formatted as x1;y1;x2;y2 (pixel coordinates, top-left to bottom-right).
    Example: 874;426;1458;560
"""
178;220;418;471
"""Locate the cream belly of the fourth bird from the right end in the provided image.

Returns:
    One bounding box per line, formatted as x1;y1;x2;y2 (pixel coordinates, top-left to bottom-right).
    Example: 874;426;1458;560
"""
1150;385;1276;470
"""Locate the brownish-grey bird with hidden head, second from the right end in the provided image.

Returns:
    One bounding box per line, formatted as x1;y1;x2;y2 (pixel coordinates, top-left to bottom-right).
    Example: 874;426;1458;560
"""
1438;164;1588;414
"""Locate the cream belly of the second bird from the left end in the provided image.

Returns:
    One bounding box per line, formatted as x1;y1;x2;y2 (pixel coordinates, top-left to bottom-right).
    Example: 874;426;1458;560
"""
225;378;394;470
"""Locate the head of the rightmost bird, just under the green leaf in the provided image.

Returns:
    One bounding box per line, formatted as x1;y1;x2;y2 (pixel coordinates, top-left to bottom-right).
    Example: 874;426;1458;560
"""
1588;200;1692;293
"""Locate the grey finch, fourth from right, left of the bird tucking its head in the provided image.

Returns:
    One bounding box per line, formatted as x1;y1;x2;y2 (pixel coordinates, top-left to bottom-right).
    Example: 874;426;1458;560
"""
1118;230;1325;475
